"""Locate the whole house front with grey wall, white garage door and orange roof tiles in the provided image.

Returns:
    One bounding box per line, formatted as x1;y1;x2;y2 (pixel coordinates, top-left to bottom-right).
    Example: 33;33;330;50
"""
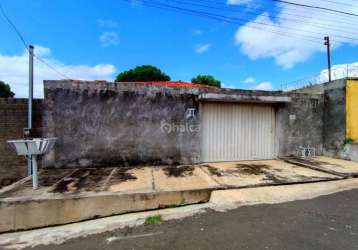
43;80;324;167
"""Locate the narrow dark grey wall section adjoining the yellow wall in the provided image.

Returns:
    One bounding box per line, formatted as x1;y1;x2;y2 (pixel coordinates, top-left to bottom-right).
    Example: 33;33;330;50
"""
323;79;346;155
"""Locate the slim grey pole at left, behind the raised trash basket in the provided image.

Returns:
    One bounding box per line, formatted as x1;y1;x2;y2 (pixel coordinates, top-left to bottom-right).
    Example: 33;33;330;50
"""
24;45;34;175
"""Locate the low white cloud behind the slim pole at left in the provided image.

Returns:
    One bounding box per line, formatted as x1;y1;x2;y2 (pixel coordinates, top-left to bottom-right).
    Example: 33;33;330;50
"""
0;46;116;98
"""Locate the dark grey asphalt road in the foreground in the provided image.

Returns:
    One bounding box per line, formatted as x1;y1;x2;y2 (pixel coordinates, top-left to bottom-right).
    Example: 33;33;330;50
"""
29;190;358;250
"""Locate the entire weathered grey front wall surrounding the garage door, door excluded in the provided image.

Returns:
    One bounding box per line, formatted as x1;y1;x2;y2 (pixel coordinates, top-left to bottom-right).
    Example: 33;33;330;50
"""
43;81;323;167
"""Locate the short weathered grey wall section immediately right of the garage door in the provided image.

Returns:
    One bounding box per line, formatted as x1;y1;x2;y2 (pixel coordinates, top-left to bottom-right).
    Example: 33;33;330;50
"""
276;93;324;157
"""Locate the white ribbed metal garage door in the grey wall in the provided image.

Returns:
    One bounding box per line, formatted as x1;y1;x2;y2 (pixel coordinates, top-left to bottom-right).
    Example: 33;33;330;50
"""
201;103;275;162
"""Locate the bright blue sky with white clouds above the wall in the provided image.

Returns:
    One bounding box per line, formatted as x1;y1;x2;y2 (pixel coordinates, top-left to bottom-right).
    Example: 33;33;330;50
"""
0;0;358;96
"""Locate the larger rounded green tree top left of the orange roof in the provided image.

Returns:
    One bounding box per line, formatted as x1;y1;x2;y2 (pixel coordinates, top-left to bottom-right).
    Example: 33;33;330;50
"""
116;65;170;82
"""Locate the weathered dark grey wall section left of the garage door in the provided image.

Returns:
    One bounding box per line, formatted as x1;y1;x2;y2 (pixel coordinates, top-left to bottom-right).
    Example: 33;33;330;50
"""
44;81;200;167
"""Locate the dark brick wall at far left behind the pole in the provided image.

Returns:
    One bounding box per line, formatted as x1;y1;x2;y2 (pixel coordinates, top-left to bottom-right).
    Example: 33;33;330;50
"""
0;98;43;188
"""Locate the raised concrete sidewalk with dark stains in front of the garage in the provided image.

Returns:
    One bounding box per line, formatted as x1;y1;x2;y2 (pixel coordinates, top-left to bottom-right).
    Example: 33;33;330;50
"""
0;160;358;232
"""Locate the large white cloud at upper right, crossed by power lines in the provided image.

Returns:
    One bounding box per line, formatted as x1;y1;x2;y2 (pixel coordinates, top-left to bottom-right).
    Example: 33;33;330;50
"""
235;0;358;68
